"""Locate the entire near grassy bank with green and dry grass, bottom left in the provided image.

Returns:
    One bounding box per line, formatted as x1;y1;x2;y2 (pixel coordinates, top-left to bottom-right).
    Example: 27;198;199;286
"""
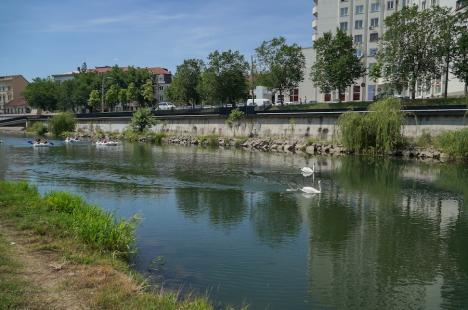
0;182;213;309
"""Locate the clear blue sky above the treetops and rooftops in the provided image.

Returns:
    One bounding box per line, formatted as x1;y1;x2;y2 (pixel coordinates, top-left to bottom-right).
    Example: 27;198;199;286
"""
0;0;313;80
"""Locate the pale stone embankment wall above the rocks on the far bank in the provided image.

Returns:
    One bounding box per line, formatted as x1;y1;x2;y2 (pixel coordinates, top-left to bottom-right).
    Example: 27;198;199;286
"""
78;113;468;142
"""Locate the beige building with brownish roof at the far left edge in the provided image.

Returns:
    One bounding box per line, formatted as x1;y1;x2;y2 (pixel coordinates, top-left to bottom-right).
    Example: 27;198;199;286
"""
0;75;29;114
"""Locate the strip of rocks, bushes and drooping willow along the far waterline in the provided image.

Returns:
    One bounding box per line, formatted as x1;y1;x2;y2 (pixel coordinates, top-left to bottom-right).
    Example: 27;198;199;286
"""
28;98;468;160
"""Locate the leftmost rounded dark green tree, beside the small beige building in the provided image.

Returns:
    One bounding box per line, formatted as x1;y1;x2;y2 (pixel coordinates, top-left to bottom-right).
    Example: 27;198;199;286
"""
23;78;59;111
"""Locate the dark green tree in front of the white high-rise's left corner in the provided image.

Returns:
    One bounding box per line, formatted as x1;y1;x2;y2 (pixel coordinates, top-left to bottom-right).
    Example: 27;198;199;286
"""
310;29;366;101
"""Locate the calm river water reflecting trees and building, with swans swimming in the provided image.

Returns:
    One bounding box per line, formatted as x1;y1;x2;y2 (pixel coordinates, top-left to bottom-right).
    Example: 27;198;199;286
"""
0;136;468;309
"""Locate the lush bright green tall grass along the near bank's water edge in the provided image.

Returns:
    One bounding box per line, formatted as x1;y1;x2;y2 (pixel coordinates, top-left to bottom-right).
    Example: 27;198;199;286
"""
0;182;136;259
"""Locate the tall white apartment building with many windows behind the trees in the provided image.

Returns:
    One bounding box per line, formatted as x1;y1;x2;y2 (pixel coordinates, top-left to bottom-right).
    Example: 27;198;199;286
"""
312;0;463;101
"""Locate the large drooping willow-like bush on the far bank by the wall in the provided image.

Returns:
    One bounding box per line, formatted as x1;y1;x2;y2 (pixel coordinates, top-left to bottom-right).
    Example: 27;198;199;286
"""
338;98;403;153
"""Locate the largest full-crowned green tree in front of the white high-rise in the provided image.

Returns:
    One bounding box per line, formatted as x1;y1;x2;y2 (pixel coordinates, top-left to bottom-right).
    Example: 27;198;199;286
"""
372;6;443;99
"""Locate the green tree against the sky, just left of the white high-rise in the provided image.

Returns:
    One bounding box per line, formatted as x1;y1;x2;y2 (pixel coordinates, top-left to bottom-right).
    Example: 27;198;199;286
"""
256;37;305;104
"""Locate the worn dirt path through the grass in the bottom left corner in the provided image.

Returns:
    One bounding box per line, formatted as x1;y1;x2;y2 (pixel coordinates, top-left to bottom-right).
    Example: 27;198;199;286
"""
0;222;90;310
